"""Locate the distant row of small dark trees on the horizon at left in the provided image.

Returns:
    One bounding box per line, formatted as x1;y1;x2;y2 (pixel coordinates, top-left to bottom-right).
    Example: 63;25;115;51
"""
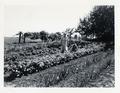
16;31;62;43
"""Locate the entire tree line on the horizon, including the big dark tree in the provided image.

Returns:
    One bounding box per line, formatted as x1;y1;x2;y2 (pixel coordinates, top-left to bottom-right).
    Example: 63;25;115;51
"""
16;6;114;43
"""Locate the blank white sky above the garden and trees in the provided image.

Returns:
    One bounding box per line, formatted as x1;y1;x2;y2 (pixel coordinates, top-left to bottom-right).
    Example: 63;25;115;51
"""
4;0;94;36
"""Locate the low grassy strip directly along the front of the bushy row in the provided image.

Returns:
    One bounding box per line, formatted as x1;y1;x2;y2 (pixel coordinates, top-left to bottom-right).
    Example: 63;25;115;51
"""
5;52;112;87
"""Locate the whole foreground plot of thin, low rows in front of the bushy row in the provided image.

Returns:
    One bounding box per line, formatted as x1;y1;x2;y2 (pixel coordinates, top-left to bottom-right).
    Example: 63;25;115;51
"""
5;52;113;87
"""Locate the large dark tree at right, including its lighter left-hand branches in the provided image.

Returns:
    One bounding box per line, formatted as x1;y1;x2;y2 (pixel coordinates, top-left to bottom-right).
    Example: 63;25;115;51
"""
77;6;114;42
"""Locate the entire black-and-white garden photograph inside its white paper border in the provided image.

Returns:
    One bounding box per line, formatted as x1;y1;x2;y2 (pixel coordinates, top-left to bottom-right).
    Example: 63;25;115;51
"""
3;0;115;88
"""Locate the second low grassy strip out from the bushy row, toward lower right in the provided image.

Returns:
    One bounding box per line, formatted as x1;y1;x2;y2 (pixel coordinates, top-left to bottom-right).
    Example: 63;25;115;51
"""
54;53;114;87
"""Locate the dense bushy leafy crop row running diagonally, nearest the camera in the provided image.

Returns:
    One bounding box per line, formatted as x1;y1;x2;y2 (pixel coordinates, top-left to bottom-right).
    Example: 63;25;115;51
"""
4;42;103;80
